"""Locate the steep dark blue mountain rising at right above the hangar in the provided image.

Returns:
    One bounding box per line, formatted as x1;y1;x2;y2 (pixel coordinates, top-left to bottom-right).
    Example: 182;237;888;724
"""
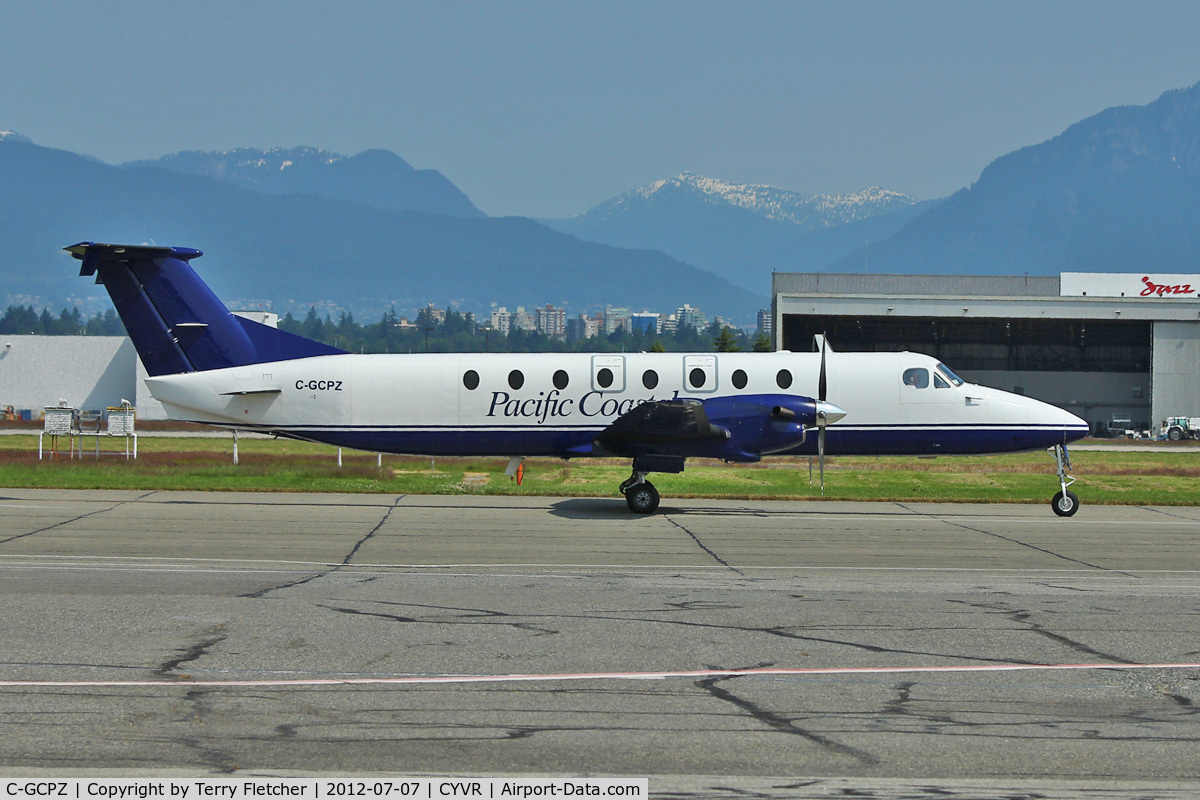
827;84;1200;275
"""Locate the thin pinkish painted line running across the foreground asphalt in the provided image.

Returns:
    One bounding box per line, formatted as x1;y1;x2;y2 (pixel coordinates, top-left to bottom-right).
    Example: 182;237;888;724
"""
0;663;1200;688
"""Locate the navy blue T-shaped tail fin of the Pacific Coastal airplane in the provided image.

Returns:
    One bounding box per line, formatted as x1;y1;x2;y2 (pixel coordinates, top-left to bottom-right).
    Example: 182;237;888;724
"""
65;242;344;375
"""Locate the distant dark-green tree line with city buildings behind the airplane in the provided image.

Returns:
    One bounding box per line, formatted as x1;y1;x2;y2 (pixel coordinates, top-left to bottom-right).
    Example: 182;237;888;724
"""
0;306;770;353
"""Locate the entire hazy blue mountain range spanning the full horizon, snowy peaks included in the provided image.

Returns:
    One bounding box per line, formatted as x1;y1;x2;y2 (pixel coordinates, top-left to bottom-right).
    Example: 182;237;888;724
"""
0;77;1200;321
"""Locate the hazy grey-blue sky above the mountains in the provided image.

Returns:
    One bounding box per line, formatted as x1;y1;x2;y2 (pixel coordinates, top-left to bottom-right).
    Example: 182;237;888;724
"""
0;0;1200;216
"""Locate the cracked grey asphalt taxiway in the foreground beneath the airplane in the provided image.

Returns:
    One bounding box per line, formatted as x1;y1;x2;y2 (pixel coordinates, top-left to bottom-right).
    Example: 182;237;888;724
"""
0;489;1200;796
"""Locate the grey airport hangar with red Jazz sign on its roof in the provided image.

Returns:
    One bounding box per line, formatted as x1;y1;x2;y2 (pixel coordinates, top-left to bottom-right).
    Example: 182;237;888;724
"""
772;272;1200;434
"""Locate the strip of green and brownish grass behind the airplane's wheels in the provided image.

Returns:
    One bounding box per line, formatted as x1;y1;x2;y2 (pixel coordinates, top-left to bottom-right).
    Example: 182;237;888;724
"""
0;435;1200;505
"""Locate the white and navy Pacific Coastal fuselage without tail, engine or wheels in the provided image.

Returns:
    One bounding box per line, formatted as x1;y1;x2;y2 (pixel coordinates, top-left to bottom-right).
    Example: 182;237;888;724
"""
148;351;1087;461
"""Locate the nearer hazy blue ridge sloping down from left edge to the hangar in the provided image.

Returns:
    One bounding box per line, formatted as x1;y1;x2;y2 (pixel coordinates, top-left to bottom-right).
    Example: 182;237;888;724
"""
0;136;767;320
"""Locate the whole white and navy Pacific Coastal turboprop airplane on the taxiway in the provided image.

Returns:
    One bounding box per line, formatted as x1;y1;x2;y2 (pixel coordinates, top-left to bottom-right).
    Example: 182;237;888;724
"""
66;242;1088;516
